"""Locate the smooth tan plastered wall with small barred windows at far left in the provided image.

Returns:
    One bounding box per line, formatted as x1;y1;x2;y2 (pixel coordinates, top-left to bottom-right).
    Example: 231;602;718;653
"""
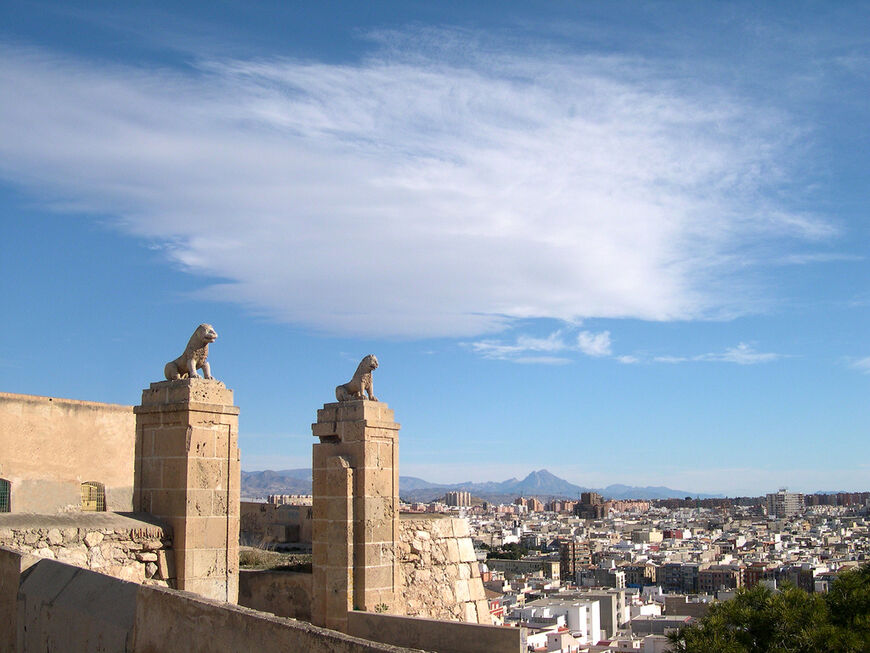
0;392;136;513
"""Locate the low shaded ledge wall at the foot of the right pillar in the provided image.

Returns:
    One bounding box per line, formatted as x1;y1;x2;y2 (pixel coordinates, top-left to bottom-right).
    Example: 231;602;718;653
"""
347;610;522;653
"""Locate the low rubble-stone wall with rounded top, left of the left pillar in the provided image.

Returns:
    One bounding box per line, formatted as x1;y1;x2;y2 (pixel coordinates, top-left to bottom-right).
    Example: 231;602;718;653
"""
0;513;174;587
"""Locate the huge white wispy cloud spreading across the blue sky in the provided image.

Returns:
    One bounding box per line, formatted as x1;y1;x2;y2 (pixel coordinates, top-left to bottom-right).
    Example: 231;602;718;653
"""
0;36;833;338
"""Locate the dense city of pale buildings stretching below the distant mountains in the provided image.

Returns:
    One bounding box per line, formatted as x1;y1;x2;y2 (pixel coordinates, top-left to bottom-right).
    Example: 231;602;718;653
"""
396;489;870;653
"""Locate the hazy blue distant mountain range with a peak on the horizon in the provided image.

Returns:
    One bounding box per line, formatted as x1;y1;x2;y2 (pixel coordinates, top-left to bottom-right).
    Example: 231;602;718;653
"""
242;469;722;503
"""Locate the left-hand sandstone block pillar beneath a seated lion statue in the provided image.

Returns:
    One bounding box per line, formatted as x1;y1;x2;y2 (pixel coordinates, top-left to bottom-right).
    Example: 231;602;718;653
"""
133;377;241;603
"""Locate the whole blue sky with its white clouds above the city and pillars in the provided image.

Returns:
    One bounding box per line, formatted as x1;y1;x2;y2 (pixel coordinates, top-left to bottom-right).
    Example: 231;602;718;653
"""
0;1;870;494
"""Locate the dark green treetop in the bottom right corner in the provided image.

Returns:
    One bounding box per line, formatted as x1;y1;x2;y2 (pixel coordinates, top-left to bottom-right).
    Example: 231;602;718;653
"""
669;566;870;653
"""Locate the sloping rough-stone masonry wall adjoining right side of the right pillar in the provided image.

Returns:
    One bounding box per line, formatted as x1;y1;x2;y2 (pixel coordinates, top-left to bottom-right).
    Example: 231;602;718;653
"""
397;515;492;624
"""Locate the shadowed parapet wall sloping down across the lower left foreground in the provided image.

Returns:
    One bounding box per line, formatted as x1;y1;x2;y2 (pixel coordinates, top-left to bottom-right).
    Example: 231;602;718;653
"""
0;547;419;653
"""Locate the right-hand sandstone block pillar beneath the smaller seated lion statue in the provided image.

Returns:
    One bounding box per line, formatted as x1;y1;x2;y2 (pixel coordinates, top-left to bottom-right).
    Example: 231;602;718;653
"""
311;399;399;630
